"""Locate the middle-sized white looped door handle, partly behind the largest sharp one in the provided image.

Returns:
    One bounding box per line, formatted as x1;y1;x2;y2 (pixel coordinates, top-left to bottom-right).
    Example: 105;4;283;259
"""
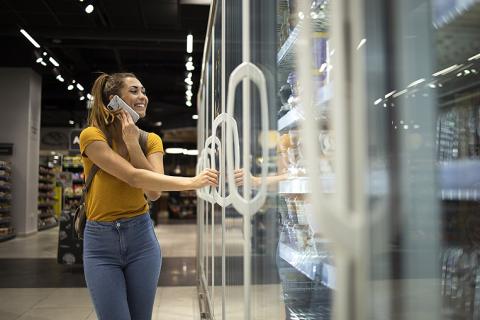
211;113;240;207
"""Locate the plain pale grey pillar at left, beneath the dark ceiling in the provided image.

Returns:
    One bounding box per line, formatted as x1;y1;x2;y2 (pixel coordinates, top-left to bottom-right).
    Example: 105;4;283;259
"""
0;68;42;235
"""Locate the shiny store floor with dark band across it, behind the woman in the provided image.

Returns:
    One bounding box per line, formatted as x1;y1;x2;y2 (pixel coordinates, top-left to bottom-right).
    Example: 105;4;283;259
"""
0;224;199;320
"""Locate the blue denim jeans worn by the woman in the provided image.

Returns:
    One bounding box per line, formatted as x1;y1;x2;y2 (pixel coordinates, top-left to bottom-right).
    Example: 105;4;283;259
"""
83;213;162;320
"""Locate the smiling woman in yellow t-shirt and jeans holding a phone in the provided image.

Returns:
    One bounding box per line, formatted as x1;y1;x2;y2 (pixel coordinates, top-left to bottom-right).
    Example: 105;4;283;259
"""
80;73;218;320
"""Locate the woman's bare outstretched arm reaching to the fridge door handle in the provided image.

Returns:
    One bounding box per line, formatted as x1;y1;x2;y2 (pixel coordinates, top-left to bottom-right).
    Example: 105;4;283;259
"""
84;141;218;192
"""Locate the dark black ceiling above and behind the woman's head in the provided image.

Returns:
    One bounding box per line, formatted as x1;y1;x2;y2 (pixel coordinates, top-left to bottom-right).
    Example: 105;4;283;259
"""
0;0;209;132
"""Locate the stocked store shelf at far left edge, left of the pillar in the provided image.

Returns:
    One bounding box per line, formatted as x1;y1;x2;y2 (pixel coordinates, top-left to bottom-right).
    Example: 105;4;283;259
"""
0;160;16;241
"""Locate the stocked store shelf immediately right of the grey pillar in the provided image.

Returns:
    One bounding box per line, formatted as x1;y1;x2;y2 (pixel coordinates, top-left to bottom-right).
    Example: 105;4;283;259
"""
37;165;58;231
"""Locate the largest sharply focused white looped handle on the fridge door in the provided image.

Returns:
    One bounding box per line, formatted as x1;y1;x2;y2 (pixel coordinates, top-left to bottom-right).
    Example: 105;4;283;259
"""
227;62;269;217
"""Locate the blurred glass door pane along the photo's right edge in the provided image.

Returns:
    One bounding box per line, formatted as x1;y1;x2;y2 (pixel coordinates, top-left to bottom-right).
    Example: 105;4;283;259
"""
429;0;480;319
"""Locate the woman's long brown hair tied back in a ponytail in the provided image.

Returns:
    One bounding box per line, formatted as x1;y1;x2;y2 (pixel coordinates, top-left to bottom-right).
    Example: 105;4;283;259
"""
88;72;137;136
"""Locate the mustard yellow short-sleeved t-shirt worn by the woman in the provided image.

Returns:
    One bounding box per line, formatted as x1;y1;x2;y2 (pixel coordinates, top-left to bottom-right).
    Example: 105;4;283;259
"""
80;127;163;221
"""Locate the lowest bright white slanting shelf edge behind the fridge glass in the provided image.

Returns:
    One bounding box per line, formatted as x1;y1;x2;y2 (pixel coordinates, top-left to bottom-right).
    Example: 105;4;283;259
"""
279;242;335;289
